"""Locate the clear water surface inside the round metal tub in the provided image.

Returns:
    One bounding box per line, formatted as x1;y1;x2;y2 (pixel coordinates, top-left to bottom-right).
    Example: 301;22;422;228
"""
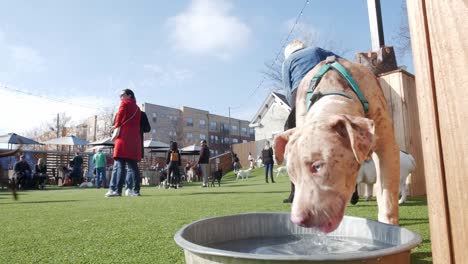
207;234;393;256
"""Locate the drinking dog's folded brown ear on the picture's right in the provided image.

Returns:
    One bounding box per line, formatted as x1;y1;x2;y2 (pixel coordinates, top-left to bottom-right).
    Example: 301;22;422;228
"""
332;115;375;164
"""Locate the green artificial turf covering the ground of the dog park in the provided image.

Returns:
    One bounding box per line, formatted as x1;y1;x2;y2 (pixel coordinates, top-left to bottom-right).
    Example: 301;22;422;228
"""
0;168;432;263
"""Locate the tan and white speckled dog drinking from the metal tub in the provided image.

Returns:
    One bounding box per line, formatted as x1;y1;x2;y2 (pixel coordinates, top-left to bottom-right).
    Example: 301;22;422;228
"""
275;59;400;233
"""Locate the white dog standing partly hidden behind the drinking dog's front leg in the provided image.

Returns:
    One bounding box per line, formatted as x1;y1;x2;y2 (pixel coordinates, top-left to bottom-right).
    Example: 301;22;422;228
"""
357;151;416;204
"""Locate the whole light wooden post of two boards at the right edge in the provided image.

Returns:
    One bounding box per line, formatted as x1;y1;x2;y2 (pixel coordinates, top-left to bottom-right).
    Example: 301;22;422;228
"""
407;0;468;264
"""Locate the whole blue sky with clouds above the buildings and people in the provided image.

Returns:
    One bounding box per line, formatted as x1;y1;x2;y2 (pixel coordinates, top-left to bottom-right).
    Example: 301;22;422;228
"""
0;0;413;134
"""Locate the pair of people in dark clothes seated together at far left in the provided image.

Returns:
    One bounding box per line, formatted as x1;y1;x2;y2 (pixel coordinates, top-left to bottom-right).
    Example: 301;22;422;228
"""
13;155;47;190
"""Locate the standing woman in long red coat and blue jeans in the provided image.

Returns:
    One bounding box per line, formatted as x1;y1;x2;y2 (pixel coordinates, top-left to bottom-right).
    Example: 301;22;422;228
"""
106;89;142;197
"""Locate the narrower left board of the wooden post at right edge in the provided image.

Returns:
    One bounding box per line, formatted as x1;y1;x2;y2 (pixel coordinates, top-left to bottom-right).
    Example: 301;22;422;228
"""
406;0;453;264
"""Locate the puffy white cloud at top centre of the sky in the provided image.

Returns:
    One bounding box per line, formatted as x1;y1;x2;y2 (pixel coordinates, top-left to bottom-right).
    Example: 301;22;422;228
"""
167;0;251;59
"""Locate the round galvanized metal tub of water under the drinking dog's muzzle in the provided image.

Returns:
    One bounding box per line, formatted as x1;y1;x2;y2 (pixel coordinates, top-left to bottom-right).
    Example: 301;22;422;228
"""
174;213;421;264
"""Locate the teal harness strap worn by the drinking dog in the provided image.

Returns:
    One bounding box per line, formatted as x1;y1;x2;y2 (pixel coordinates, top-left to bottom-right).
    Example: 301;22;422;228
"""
306;56;369;113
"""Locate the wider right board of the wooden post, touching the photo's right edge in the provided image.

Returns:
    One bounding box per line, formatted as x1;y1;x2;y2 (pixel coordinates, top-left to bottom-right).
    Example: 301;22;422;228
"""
426;0;468;263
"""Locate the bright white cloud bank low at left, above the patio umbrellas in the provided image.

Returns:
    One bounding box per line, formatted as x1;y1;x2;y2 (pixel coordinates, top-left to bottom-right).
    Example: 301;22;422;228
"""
0;83;115;135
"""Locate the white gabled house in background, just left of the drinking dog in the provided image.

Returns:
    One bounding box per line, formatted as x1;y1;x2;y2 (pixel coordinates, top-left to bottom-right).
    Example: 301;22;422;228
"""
249;92;291;142
